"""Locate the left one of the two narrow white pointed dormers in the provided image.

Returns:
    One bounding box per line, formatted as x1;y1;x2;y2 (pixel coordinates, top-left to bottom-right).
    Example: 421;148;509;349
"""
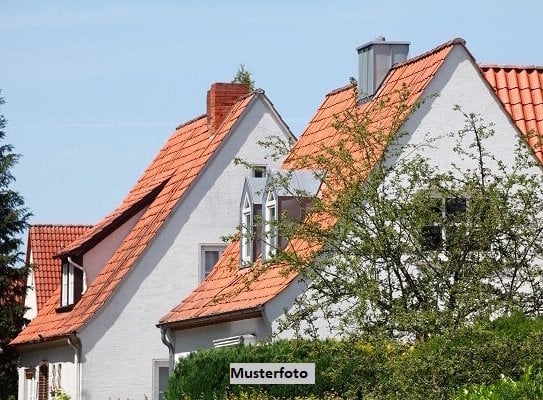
240;174;266;266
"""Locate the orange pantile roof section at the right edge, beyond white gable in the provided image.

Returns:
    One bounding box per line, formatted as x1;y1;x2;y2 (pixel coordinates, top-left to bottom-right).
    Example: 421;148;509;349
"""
480;65;543;162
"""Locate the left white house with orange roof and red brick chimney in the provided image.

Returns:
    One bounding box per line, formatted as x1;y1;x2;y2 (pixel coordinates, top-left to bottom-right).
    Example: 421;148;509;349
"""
12;83;293;400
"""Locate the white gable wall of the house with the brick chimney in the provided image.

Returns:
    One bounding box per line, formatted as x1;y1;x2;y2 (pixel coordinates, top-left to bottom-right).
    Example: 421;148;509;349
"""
76;97;294;400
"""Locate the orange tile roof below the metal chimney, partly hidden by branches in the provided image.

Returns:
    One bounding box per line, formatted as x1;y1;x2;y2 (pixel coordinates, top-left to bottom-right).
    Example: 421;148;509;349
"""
160;39;465;329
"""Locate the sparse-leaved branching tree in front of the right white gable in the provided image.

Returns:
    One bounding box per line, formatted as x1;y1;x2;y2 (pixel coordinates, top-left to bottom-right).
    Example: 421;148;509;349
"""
258;86;543;340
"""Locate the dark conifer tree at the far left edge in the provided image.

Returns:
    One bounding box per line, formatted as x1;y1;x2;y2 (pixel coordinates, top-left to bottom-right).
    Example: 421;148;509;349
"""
0;91;30;399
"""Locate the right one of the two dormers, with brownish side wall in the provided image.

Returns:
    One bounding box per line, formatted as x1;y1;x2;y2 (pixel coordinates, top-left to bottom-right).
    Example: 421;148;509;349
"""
261;171;320;260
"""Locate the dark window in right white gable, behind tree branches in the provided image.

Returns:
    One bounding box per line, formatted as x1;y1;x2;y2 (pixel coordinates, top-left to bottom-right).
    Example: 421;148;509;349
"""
422;197;467;250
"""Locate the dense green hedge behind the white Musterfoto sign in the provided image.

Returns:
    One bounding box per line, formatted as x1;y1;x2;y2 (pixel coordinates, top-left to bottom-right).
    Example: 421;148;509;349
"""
166;315;543;400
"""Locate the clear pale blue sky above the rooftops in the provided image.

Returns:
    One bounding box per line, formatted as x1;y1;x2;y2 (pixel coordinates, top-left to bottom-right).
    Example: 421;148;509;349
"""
0;0;543;230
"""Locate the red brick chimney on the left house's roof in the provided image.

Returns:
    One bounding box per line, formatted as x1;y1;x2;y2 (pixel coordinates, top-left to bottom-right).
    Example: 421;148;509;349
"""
207;83;249;132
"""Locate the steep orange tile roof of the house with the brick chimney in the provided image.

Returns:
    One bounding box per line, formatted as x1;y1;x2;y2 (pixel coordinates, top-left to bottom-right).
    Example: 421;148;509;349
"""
12;85;260;344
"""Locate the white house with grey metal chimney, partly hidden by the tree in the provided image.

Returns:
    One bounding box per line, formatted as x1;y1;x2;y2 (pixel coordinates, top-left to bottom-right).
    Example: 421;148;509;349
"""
158;38;543;361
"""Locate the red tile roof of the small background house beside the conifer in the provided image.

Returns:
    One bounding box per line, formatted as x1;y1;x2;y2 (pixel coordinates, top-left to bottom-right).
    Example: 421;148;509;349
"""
26;225;91;312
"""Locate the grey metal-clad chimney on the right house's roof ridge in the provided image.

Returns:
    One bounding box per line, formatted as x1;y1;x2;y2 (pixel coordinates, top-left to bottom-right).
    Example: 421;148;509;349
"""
356;36;410;101
